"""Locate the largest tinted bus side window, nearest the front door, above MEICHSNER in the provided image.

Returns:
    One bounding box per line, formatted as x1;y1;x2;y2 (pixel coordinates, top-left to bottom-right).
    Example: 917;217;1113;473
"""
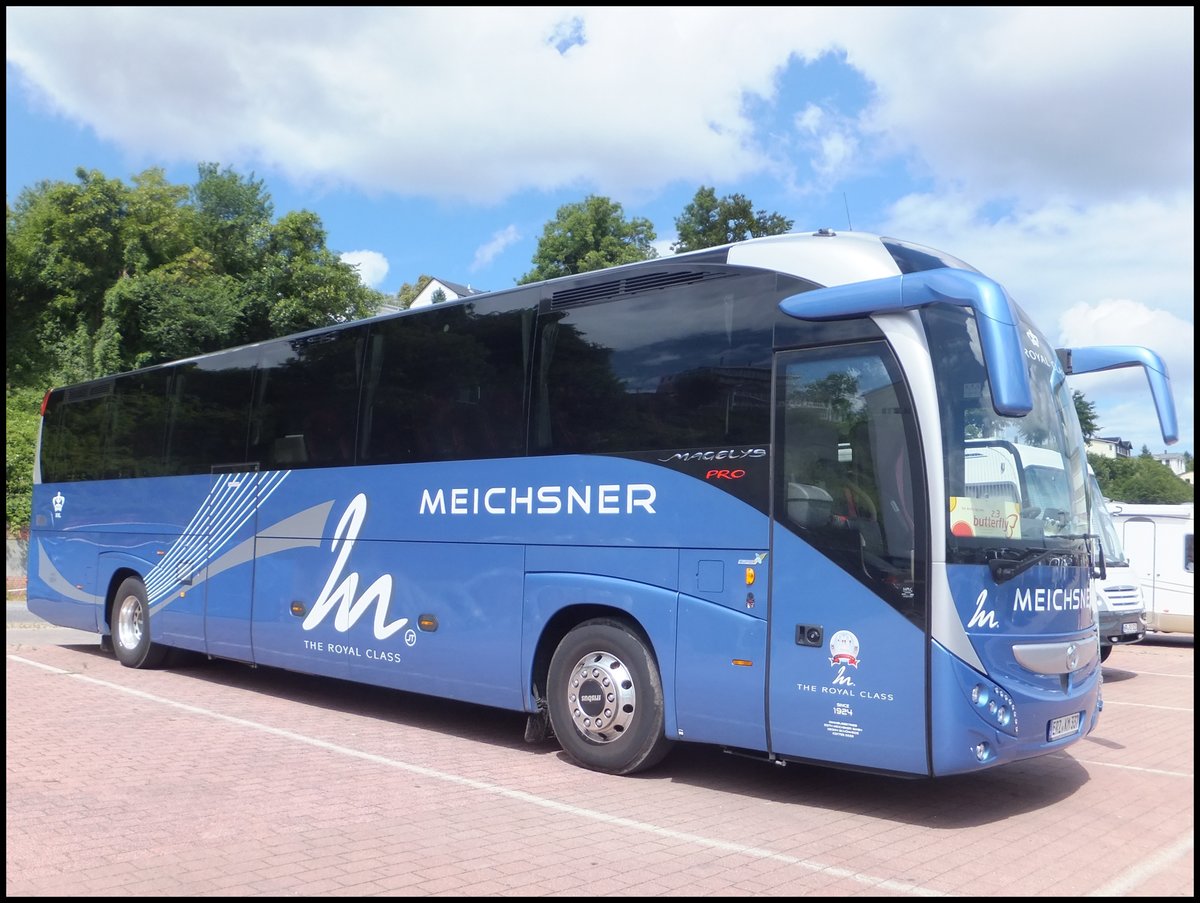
532;266;777;454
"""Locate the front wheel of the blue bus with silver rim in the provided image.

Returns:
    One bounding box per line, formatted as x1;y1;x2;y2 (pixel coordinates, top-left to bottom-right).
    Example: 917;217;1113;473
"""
546;618;671;775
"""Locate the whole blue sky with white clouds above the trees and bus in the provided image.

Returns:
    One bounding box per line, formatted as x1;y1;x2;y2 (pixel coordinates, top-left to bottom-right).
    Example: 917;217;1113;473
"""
5;6;1195;454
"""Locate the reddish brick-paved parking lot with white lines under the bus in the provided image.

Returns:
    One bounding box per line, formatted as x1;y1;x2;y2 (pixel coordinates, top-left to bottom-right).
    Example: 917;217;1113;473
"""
5;617;1195;898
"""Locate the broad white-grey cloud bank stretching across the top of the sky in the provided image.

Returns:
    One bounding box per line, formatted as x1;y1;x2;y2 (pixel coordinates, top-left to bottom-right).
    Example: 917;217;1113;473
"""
6;6;1194;202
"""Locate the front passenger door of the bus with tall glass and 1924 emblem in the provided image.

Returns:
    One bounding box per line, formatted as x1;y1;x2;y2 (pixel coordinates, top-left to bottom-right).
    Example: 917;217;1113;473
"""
767;341;928;775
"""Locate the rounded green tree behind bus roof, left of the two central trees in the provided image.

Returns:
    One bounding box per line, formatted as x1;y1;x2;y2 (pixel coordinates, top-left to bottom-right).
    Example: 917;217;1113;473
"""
517;195;658;285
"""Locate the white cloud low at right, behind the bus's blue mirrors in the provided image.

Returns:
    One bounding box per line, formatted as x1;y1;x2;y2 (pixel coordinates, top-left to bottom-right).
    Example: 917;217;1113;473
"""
881;192;1195;454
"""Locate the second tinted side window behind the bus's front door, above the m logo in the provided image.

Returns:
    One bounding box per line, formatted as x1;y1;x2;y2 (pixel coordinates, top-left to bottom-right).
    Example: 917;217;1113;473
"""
360;298;534;464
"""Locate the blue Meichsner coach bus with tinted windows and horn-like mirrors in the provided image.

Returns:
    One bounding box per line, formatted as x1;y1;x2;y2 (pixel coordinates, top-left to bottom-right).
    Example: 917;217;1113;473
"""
28;229;1177;777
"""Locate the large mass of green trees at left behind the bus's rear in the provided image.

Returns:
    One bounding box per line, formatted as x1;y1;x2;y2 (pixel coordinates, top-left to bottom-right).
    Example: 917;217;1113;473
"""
5;163;383;530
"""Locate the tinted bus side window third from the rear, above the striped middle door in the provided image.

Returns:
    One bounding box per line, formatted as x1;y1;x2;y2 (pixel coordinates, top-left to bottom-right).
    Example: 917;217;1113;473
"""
167;348;257;473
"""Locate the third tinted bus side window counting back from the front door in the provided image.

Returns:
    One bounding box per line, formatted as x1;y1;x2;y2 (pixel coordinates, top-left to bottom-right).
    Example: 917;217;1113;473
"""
250;327;366;470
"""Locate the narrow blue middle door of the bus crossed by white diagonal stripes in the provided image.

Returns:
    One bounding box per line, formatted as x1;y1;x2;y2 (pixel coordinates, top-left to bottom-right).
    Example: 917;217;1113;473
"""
203;465;260;662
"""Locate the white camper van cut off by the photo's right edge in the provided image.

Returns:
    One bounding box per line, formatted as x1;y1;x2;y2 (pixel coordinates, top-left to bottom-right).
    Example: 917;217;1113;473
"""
1110;502;1195;633
